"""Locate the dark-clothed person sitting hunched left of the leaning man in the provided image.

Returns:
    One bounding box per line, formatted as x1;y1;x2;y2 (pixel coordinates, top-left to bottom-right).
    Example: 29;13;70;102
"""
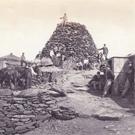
88;71;101;90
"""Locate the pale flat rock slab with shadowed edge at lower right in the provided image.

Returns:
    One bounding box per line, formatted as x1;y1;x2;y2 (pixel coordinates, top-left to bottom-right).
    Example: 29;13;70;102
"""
91;108;124;121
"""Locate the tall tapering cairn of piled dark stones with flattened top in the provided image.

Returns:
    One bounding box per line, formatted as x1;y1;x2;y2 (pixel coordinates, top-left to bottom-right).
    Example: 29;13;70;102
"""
42;22;97;66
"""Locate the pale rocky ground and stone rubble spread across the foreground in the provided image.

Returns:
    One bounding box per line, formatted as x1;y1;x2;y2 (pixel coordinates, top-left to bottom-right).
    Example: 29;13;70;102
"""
0;71;135;135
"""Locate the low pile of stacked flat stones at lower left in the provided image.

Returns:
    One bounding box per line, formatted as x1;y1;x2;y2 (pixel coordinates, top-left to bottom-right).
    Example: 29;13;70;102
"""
0;93;77;135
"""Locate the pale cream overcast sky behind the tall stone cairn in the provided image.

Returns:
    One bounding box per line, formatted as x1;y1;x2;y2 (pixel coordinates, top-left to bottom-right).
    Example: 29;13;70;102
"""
0;0;135;60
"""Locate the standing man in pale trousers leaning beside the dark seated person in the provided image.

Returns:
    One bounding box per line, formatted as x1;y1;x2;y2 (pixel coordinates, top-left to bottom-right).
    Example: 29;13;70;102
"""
100;65;115;97
